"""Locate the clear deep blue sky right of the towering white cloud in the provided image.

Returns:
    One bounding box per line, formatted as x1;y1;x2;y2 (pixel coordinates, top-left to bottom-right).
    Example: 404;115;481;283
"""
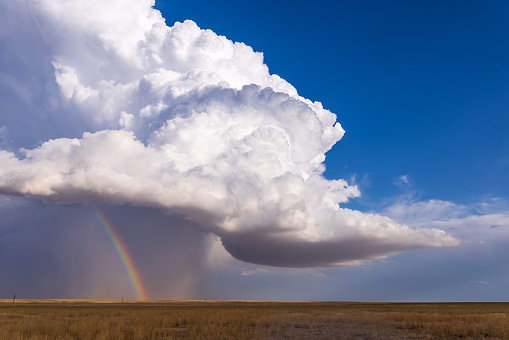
156;0;509;210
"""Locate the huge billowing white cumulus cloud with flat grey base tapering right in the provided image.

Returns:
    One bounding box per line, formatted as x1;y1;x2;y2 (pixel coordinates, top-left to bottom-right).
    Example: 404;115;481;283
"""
0;0;458;267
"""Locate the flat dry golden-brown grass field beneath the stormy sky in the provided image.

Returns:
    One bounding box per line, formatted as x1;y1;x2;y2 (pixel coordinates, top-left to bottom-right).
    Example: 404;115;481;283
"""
0;300;509;340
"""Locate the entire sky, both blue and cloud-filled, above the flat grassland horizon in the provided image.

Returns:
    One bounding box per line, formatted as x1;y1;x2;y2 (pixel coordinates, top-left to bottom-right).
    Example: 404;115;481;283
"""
0;0;509;301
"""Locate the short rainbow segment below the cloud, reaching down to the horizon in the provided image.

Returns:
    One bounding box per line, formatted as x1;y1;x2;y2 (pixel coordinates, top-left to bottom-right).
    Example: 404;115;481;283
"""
92;206;148;300
